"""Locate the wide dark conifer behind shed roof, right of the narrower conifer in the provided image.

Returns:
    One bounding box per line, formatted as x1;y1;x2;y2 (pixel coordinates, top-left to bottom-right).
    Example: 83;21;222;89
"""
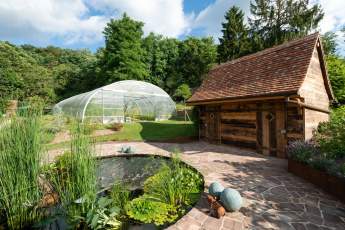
248;0;324;48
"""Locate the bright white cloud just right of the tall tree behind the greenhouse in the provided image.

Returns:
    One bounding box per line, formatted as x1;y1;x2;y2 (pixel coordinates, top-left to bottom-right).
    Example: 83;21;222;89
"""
89;0;193;37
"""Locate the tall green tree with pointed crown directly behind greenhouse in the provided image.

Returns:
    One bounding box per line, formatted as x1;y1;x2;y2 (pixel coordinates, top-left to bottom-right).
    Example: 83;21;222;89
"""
100;14;148;83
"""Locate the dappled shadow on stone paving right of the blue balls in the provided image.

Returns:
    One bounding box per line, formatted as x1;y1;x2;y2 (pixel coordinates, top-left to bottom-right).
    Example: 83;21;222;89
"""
215;160;345;229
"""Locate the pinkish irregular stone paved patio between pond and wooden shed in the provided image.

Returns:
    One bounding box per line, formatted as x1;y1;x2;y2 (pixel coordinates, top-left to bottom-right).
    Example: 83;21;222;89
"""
49;142;345;230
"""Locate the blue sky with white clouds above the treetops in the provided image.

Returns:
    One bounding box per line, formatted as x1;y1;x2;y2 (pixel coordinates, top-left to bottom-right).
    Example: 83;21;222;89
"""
0;0;345;54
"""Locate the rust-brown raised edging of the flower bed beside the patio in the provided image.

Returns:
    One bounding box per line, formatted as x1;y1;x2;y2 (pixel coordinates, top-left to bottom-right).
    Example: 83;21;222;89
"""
288;159;345;203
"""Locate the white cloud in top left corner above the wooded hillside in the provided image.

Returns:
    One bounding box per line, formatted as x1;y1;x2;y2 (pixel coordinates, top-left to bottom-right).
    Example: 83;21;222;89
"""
0;0;107;44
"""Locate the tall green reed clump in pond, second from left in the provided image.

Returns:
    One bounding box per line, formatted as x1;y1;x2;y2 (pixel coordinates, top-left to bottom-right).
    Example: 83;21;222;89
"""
50;124;96;224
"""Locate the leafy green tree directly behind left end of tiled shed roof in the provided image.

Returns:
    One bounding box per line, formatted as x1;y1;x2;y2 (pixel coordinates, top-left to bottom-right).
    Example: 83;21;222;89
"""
175;37;217;88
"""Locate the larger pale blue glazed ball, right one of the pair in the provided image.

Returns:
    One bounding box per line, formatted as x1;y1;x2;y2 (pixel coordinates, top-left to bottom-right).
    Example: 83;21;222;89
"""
220;188;243;212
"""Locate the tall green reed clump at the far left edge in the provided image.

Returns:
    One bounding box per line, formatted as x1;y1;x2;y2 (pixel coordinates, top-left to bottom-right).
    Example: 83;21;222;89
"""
0;110;42;229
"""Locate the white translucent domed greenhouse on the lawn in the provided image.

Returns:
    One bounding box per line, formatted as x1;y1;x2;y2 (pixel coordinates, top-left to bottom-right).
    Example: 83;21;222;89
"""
53;80;176;123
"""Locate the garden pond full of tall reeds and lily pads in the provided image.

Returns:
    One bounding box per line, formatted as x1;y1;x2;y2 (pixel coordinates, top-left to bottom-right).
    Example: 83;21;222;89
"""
0;111;204;229
